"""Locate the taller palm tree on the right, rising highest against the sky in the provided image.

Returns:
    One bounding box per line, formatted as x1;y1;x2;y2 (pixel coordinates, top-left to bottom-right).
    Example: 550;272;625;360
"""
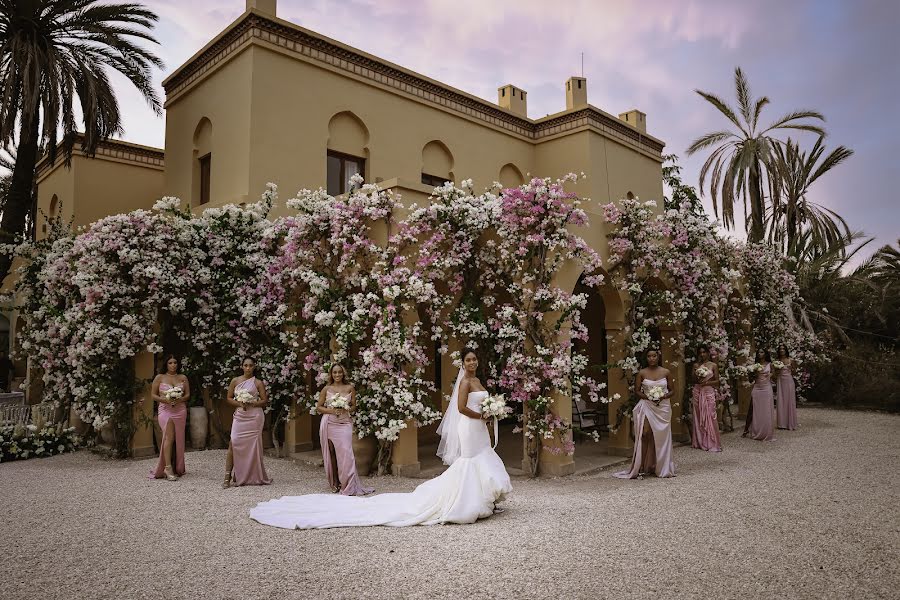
687;67;825;242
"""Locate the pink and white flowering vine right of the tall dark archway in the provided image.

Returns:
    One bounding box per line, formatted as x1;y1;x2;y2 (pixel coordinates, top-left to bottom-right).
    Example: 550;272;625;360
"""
603;198;819;428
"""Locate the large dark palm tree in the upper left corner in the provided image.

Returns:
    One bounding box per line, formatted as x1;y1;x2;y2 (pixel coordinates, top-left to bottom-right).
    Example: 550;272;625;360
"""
0;0;162;281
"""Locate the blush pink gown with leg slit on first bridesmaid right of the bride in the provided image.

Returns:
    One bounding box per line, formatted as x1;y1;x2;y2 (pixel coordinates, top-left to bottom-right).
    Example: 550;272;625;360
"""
613;379;675;479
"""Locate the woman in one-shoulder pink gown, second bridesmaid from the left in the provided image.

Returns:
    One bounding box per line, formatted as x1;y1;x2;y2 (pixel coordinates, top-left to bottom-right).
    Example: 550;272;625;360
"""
222;357;272;488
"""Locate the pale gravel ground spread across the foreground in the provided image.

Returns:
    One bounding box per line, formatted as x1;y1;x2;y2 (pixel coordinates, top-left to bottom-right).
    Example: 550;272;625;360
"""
0;409;900;600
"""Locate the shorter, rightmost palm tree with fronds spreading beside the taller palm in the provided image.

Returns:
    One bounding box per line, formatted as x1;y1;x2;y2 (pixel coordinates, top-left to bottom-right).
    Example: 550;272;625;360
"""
766;137;853;251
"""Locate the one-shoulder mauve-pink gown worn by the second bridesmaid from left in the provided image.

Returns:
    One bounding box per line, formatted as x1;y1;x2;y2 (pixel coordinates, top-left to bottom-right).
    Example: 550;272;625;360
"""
231;377;272;485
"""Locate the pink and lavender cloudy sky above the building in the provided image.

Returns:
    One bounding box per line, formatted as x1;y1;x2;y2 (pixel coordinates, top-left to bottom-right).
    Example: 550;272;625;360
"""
109;0;900;255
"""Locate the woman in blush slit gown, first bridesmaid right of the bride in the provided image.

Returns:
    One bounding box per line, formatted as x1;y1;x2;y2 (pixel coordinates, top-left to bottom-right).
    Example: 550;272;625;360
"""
613;350;675;479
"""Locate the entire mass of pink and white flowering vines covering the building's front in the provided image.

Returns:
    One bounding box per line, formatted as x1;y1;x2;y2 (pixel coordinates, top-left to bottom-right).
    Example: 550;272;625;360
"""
3;164;816;474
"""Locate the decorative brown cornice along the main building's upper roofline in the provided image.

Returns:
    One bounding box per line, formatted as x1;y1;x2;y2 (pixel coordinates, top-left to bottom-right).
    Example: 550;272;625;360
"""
163;11;665;155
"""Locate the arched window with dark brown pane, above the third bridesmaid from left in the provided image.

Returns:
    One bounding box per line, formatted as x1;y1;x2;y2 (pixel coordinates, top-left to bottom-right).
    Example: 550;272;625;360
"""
326;111;369;196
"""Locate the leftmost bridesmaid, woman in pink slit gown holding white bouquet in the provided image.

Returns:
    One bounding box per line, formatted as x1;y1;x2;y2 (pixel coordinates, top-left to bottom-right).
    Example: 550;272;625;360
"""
150;354;191;481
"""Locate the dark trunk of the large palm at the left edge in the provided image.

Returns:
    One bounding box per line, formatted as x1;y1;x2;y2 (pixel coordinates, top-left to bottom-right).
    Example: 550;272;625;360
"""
0;111;38;282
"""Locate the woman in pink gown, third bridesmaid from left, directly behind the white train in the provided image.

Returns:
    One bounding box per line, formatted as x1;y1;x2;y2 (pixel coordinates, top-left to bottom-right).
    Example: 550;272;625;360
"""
316;364;375;496
